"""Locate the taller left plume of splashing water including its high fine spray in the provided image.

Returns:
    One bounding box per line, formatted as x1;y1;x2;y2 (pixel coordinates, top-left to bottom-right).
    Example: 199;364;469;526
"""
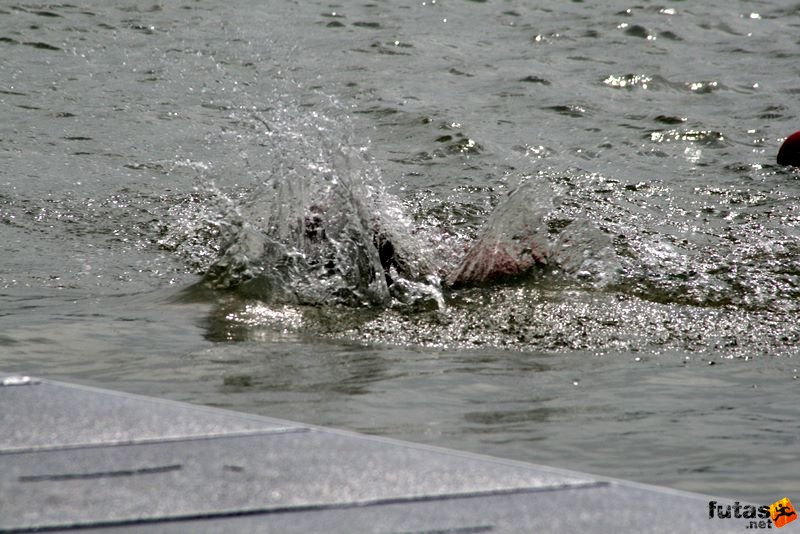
198;100;436;306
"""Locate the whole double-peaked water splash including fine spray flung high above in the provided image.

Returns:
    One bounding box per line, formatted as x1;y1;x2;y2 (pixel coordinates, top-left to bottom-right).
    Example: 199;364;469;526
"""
177;88;620;311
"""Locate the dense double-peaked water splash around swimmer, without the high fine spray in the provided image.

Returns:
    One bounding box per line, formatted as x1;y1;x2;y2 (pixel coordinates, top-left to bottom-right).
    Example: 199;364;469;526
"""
198;161;616;310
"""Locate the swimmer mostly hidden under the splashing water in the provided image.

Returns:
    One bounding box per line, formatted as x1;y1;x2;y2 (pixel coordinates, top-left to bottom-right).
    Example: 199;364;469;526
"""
206;176;552;307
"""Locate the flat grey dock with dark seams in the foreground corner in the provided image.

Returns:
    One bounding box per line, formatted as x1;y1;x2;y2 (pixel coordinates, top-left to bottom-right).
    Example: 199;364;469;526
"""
0;374;749;534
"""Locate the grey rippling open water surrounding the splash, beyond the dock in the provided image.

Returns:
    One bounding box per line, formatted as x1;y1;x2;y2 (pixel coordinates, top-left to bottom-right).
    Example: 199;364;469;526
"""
0;0;800;503
